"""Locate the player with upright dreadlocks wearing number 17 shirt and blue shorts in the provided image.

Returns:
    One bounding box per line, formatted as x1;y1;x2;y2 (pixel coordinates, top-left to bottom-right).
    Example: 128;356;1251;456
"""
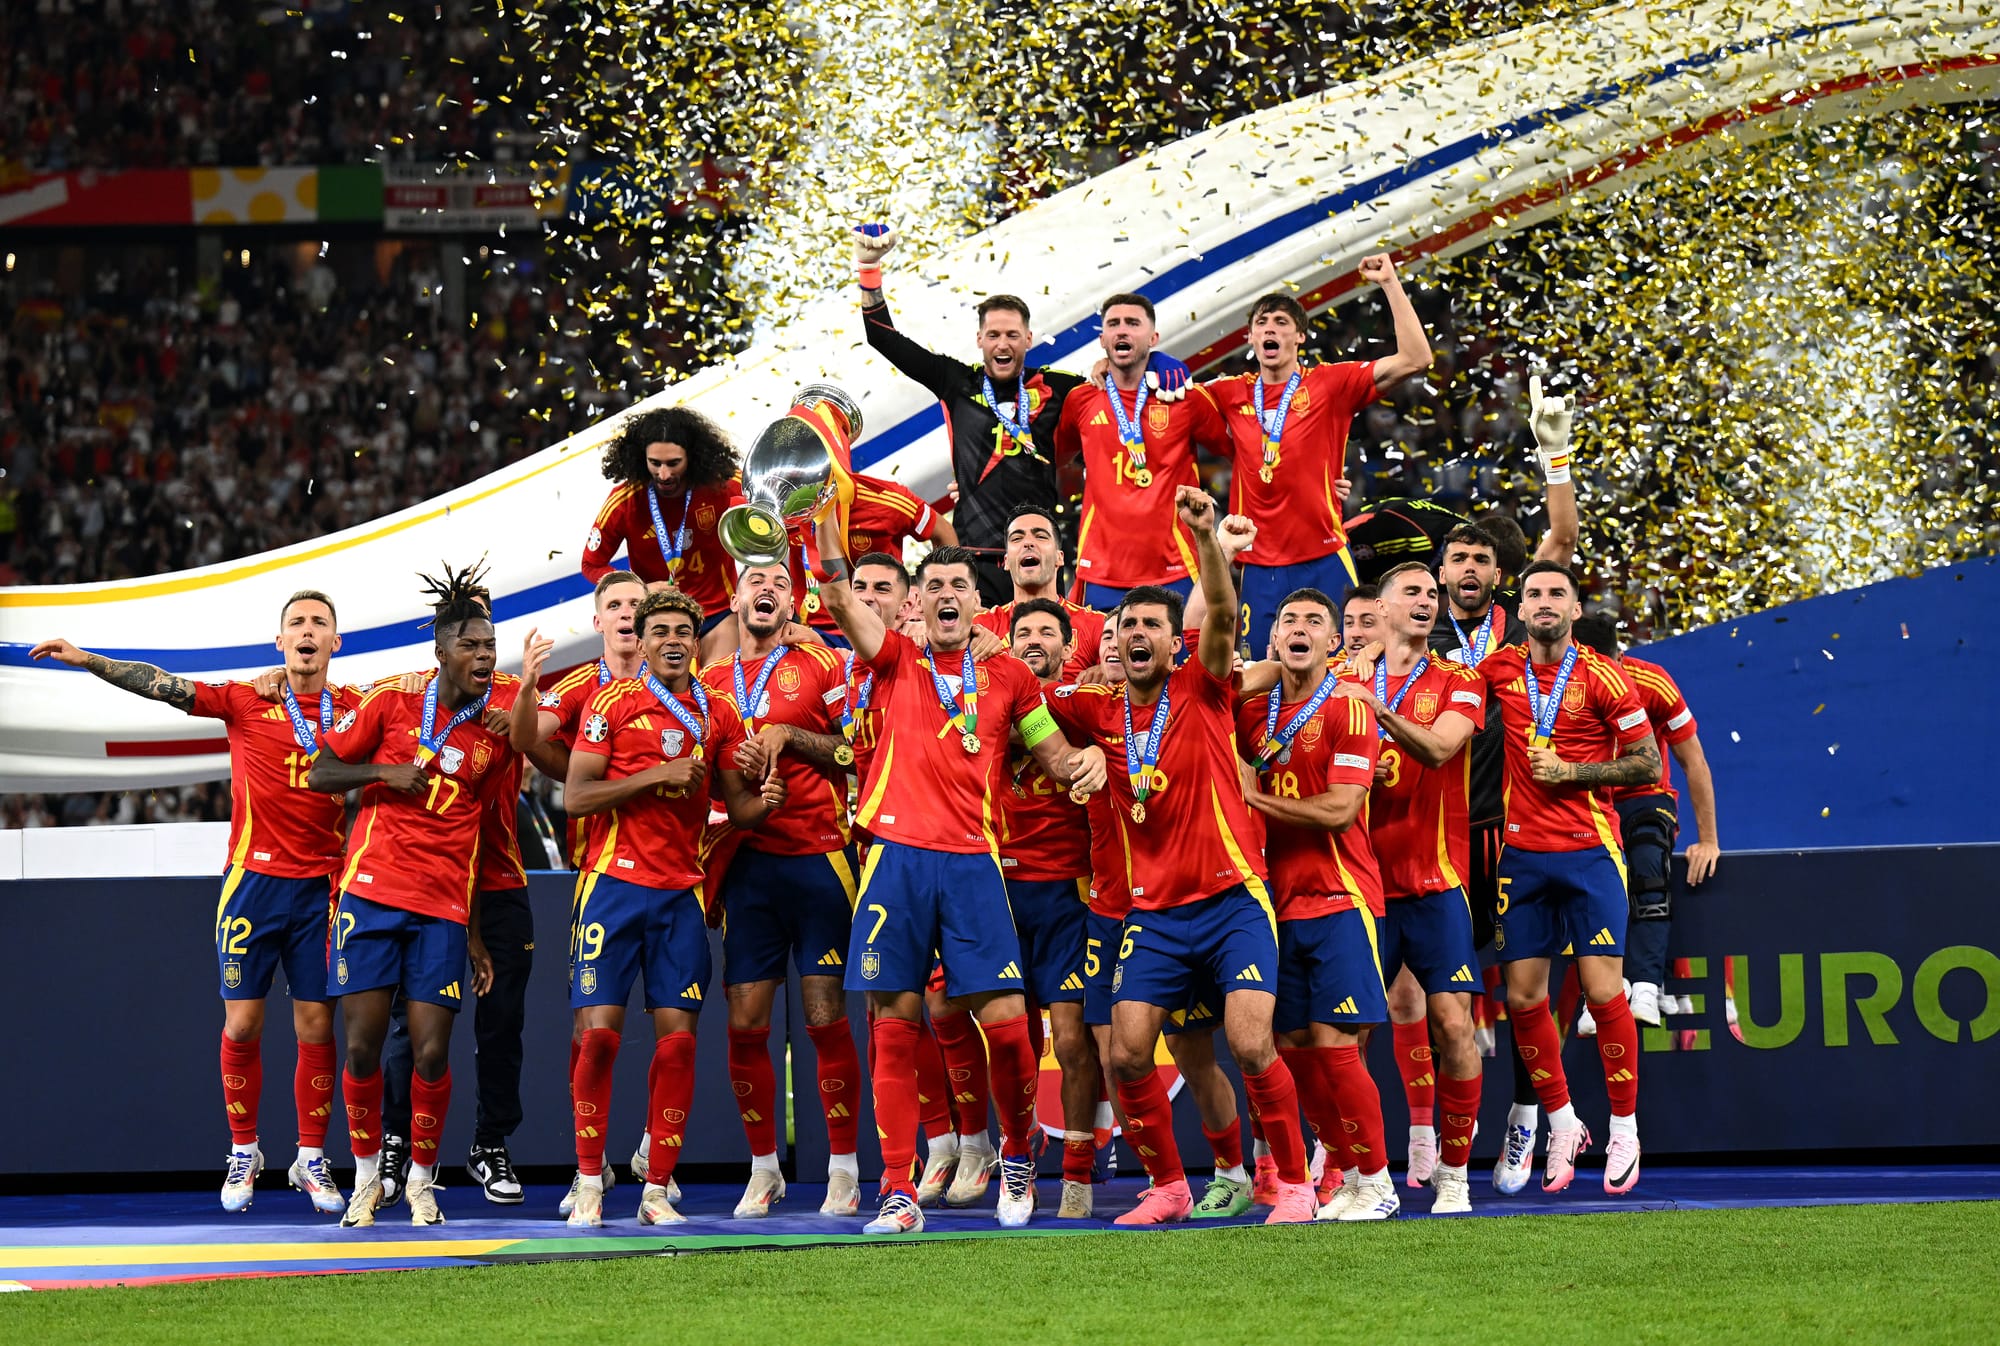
312;566;514;1226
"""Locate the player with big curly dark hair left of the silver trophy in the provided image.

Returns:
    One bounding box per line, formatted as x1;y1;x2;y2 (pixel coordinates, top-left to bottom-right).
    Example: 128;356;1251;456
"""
584;406;744;630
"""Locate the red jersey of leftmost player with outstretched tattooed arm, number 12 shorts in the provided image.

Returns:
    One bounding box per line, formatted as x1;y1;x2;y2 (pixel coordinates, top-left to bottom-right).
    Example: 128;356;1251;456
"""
188;682;362;878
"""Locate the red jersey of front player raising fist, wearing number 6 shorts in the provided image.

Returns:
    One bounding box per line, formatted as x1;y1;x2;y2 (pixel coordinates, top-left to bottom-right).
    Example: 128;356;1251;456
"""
1048;658;1270;910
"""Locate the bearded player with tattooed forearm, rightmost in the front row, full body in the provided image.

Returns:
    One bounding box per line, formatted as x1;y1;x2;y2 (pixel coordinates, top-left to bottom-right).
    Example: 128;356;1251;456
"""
1480;560;1660;1194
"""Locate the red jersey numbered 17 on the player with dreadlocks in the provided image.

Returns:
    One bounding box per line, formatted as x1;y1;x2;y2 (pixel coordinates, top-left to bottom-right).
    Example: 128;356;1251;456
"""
324;686;516;924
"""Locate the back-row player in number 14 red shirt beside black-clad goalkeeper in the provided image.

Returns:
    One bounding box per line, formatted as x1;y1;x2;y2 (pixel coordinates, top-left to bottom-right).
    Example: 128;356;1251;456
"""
1056;294;1230;612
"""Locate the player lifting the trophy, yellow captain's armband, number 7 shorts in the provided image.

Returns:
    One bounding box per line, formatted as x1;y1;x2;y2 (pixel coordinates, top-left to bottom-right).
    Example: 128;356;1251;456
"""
820;510;1104;1234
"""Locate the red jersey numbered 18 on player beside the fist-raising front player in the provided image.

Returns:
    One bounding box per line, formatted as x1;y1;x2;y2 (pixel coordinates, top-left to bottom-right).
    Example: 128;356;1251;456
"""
1236;674;1384;920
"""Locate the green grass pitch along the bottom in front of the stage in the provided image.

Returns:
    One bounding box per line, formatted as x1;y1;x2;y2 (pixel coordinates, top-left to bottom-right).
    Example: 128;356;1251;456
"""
0;1202;2000;1346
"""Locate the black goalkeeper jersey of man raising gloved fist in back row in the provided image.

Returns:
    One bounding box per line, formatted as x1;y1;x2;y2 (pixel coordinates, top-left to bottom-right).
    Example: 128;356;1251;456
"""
862;304;1084;552
